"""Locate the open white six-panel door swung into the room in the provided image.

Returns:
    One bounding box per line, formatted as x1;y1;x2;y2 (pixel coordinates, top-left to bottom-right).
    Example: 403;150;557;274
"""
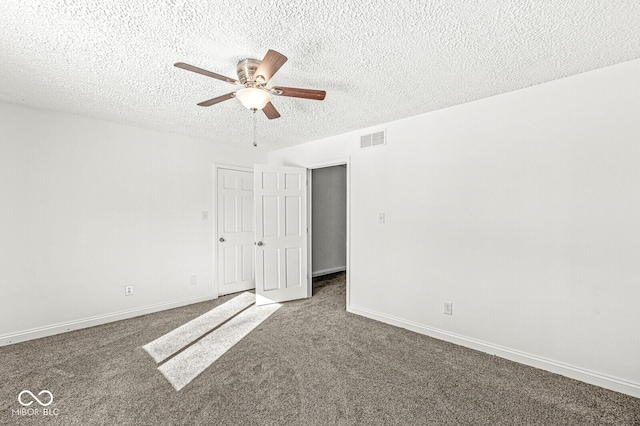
254;166;311;305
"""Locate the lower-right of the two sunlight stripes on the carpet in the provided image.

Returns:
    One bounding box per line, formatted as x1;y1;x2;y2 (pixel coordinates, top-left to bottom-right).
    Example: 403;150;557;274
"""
158;303;282;391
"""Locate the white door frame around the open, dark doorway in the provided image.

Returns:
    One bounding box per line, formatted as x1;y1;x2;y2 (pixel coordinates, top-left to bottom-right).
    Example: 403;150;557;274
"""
302;157;351;309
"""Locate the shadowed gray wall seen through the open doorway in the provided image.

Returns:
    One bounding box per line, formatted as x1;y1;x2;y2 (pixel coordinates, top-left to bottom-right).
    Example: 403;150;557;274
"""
311;166;347;276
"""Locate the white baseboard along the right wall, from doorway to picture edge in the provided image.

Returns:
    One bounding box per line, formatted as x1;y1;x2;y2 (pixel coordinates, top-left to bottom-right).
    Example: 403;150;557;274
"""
347;305;640;398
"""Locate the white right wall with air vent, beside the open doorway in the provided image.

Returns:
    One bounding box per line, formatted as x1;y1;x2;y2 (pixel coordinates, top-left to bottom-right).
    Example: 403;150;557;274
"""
269;60;640;396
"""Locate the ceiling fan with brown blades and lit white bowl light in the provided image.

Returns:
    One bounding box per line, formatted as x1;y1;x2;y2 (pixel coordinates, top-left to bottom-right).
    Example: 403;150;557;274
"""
174;50;326;120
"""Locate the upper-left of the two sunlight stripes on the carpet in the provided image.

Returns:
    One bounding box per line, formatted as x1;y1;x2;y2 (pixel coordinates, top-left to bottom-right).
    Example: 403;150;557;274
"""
143;292;256;362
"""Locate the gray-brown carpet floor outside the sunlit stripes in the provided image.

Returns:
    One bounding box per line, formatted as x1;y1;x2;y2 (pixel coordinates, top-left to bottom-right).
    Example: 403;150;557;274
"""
0;274;640;425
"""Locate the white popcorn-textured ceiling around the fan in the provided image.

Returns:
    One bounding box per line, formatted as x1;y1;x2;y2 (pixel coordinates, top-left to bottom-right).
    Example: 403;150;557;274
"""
0;0;640;149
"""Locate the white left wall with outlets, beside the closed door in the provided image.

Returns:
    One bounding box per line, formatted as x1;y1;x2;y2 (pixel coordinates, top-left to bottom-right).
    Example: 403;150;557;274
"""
0;103;266;345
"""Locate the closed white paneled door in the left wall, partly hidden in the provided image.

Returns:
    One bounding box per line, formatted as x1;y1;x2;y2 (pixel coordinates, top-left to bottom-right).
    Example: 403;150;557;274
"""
216;168;255;295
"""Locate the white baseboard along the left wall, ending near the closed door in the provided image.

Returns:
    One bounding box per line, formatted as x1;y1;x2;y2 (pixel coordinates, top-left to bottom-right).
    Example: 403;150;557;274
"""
0;294;217;346
